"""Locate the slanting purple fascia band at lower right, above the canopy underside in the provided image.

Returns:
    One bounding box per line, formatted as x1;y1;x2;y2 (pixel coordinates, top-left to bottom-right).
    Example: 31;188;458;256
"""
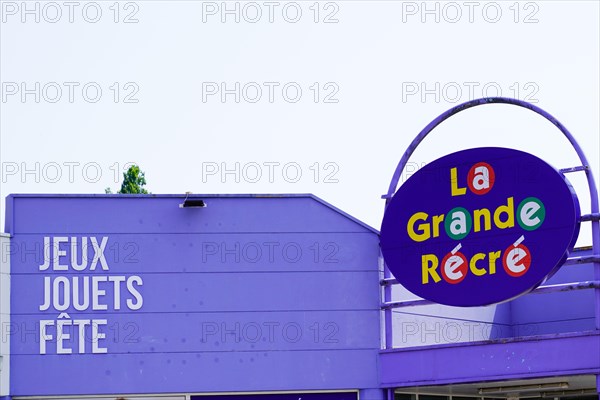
380;332;600;387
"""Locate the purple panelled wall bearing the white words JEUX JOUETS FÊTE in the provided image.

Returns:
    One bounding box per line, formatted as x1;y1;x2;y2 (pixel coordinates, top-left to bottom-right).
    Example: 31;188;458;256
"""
6;195;380;396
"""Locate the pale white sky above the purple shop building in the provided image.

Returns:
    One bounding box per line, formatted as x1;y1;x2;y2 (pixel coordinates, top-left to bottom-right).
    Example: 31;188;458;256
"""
0;1;600;245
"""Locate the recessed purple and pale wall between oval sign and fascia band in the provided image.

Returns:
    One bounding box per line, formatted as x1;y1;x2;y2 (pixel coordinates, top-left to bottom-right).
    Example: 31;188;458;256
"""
393;249;595;348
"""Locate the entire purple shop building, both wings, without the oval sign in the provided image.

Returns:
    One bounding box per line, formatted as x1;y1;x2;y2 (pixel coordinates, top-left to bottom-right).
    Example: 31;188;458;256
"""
0;195;600;400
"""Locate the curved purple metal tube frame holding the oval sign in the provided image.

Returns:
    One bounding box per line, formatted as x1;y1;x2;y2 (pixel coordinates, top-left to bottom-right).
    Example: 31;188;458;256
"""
382;97;600;349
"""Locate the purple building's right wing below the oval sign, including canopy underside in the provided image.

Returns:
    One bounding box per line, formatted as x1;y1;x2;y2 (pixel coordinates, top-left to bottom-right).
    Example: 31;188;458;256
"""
380;244;600;399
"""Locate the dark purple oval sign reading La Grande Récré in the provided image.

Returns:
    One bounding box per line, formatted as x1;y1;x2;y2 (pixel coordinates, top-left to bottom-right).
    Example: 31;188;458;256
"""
381;147;580;307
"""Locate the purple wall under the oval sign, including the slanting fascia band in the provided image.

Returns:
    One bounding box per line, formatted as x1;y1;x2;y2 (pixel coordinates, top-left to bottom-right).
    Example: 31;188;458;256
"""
380;249;600;387
